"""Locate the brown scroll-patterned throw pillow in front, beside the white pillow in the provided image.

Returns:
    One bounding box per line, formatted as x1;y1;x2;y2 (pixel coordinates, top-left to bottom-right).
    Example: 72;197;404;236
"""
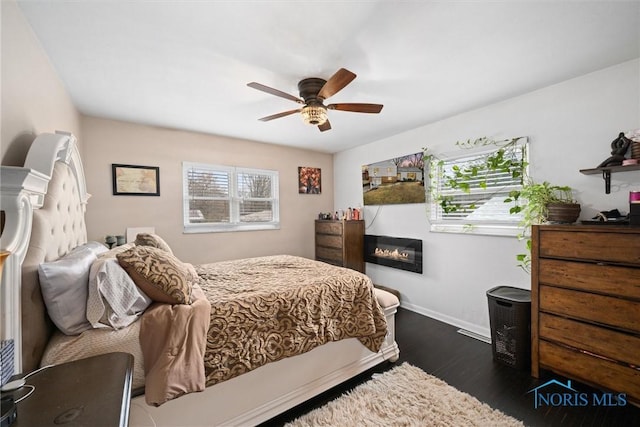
116;246;195;304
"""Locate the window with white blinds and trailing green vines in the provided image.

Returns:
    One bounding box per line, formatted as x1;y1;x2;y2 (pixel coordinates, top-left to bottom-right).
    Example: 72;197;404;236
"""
429;138;528;236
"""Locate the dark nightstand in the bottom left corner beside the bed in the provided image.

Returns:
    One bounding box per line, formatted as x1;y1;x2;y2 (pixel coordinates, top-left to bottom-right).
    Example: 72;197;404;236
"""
3;353;133;427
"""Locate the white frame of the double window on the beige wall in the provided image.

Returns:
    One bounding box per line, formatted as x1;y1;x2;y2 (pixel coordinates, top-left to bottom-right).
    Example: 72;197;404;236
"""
182;161;280;233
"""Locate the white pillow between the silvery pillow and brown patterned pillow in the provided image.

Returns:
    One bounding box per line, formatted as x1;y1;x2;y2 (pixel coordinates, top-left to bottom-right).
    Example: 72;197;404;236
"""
87;257;151;329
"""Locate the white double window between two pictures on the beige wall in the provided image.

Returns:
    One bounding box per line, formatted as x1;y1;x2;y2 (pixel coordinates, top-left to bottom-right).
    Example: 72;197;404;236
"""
182;162;280;233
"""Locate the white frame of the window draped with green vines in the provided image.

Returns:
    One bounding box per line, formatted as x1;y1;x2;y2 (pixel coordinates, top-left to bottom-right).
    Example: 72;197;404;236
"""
426;137;529;237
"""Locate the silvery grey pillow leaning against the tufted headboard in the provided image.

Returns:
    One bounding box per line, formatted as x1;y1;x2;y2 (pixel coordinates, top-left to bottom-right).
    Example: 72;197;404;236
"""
38;246;96;335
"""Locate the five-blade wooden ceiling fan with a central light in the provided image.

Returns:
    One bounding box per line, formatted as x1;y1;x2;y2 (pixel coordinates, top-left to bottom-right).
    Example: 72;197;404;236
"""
247;68;383;132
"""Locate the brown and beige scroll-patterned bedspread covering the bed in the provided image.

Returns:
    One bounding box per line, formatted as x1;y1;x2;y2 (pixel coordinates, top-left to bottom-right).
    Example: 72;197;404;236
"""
196;255;387;386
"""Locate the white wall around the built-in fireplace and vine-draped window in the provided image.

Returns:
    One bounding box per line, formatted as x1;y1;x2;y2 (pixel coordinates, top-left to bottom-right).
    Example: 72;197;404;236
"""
334;60;640;336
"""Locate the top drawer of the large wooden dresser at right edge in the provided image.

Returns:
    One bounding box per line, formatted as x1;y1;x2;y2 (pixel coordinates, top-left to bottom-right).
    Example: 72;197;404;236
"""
539;228;640;265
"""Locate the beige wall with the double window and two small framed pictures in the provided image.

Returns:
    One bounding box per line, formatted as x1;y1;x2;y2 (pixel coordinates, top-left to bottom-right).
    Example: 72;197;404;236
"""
82;116;334;264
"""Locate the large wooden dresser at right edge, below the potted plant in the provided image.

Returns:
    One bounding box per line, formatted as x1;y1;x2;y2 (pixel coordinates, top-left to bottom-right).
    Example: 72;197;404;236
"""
531;225;640;402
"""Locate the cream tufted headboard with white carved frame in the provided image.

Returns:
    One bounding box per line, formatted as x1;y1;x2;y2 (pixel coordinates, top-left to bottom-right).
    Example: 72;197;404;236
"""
0;133;89;372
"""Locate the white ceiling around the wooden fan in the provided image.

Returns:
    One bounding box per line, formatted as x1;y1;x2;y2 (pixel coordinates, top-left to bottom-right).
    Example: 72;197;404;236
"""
18;0;640;152
